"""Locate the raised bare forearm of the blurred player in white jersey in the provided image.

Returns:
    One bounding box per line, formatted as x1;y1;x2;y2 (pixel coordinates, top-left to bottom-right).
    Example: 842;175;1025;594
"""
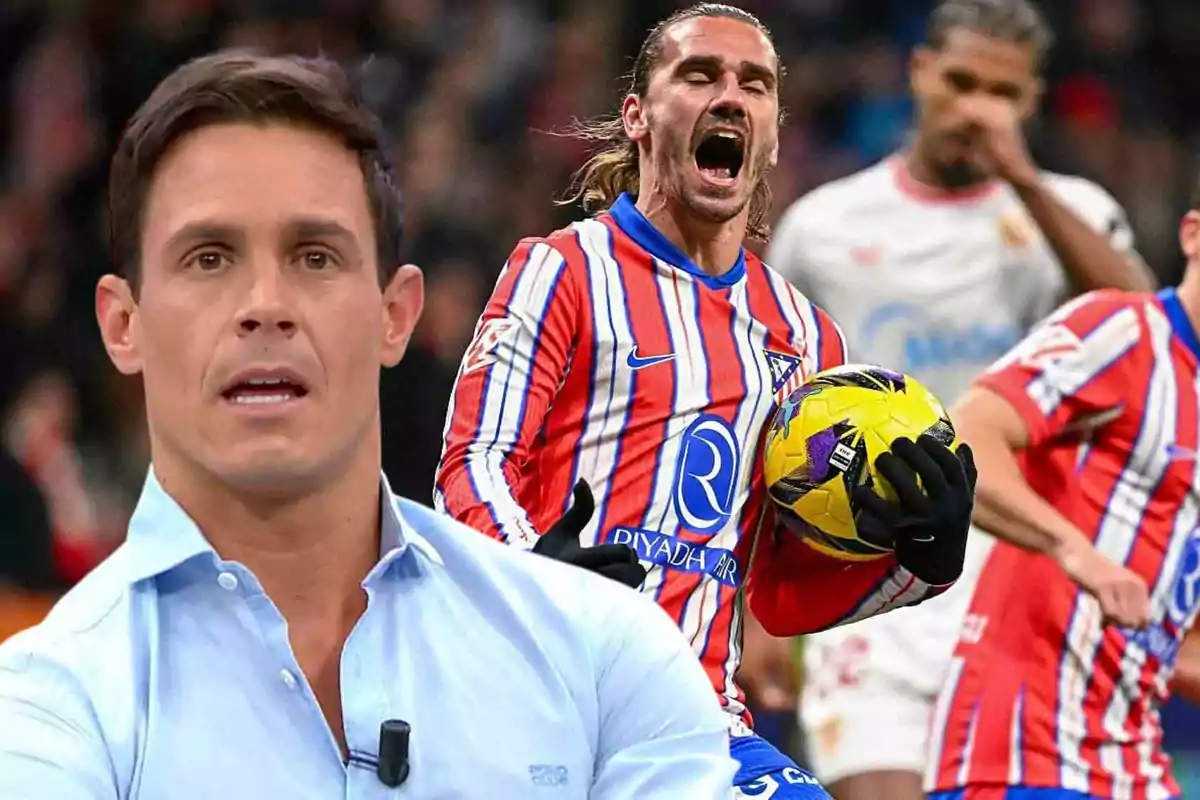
1014;178;1154;291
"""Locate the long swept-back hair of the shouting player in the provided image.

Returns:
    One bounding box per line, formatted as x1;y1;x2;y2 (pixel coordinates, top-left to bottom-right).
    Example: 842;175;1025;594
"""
563;2;774;241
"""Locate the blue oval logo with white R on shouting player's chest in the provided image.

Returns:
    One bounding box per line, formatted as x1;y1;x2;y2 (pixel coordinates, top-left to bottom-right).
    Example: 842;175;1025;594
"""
674;414;742;534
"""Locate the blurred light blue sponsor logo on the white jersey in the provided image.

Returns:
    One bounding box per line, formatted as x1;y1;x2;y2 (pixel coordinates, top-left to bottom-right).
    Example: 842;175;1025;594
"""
857;302;1021;374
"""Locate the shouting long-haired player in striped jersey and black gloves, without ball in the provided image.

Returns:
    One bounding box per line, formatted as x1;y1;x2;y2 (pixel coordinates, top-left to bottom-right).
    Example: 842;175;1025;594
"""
436;4;974;796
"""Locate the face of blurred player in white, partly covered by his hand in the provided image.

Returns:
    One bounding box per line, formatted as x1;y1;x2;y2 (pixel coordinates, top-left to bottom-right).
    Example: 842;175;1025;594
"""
912;28;1040;187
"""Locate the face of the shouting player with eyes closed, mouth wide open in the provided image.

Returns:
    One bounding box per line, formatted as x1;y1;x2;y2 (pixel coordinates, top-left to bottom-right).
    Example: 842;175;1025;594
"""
622;17;779;223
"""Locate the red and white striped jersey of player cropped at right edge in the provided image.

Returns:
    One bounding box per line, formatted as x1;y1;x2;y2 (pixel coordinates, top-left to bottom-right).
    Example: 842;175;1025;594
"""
929;290;1200;800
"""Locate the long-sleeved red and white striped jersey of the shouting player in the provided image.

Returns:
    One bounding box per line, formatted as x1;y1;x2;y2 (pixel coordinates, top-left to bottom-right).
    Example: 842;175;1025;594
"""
434;197;940;714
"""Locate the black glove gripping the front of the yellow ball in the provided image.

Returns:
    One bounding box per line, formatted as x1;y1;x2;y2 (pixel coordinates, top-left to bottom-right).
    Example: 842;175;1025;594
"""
854;435;977;585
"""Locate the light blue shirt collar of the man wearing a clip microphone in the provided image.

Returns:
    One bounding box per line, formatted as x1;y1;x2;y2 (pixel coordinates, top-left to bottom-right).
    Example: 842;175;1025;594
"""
125;468;443;583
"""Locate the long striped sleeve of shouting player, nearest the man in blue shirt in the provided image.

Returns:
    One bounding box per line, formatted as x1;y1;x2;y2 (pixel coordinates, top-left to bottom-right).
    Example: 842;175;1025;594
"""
433;239;581;548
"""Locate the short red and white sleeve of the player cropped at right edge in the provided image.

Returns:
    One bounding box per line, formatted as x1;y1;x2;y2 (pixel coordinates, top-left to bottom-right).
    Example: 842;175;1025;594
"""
976;289;1147;446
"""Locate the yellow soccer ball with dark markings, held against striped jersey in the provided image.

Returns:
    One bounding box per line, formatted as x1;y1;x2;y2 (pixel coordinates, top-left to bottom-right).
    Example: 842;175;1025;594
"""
763;365;956;561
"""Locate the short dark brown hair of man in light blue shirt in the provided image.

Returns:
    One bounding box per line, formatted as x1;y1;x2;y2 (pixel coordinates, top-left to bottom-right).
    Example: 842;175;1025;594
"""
108;49;403;289
